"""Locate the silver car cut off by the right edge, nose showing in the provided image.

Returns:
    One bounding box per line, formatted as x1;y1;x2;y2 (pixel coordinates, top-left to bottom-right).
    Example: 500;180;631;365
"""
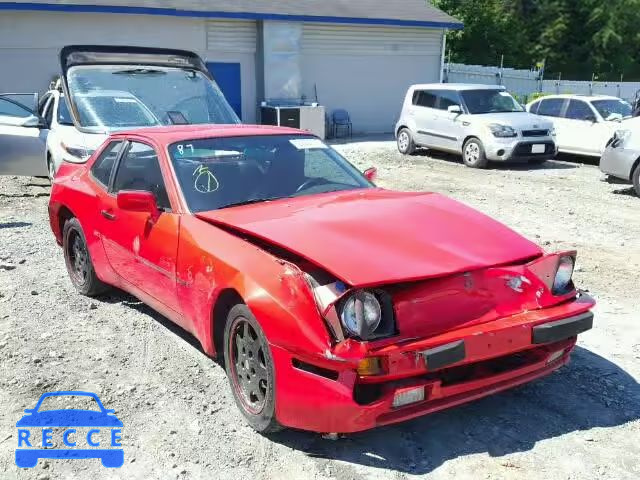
600;117;640;197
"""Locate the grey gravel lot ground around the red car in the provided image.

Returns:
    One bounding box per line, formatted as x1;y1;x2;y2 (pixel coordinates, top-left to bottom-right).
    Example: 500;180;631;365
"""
0;142;640;480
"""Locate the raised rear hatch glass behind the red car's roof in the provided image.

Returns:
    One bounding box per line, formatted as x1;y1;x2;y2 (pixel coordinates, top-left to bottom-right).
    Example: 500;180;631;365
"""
67;65;240;131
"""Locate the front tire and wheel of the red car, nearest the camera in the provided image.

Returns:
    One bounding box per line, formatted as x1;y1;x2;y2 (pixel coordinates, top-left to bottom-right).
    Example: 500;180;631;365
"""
224;304;282;434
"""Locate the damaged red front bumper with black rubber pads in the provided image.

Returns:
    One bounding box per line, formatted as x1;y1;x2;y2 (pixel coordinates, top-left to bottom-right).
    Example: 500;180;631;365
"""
272;295;595;433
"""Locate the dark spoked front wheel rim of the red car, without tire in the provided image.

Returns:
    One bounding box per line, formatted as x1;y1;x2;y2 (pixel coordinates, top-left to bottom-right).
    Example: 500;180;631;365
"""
229;318;268;415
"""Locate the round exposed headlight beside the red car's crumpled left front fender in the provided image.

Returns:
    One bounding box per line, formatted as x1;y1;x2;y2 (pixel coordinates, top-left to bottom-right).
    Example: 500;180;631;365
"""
340;290;382;340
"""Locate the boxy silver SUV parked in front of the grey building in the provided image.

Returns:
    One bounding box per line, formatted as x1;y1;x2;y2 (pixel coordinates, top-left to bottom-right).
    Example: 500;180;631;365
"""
395;83;557;168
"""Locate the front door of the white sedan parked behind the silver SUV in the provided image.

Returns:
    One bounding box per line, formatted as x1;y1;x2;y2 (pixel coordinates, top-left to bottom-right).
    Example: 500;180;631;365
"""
561;98;609;155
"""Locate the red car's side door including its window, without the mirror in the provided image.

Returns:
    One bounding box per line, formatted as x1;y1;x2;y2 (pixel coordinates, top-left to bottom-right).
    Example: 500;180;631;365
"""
98;141;180;314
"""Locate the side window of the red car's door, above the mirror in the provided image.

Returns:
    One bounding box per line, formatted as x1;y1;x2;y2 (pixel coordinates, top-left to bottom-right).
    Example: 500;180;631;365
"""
113;142;171;210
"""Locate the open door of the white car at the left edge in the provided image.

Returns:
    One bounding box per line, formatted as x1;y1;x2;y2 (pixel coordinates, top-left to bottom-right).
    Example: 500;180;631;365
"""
0;94;49;176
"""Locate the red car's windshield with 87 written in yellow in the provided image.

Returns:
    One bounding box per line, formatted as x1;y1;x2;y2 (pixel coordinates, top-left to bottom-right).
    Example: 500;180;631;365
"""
169;135;373;212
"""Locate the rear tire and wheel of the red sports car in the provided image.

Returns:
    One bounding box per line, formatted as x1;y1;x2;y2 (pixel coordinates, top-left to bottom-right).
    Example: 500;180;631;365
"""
62;218;109;297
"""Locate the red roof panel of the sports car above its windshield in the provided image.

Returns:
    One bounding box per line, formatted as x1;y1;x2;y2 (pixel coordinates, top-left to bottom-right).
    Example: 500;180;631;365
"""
110;124;313;144
